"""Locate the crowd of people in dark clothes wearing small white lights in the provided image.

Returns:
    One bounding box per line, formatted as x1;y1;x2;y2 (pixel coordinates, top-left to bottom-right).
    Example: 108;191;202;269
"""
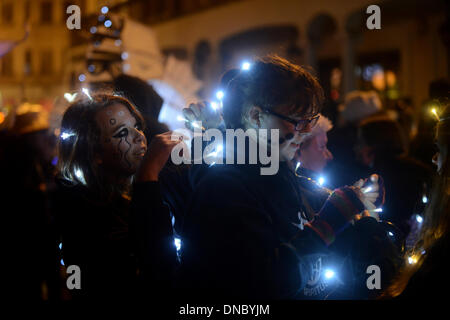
0;56;450;301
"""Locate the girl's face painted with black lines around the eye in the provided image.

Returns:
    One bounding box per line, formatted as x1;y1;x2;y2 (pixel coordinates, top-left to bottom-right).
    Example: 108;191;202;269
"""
96;103;147;176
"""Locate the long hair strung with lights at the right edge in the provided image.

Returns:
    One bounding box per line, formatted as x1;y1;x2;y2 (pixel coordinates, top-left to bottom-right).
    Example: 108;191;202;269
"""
383;105;450;298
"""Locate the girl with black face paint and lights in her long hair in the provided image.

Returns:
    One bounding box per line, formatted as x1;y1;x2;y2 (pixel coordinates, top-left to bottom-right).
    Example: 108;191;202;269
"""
57;94;182;299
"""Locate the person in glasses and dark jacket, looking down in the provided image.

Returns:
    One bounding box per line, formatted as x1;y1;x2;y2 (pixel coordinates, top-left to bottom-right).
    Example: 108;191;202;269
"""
179;57;386;299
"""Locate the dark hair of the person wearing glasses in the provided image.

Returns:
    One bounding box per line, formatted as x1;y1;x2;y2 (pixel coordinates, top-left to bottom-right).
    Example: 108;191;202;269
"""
223;56;324;128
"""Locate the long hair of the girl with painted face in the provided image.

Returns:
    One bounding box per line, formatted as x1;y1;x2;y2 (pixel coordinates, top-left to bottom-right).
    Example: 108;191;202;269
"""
58;94;144;199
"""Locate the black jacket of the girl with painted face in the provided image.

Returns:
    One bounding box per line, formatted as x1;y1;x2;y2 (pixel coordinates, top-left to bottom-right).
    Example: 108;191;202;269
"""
57;182;176;300
